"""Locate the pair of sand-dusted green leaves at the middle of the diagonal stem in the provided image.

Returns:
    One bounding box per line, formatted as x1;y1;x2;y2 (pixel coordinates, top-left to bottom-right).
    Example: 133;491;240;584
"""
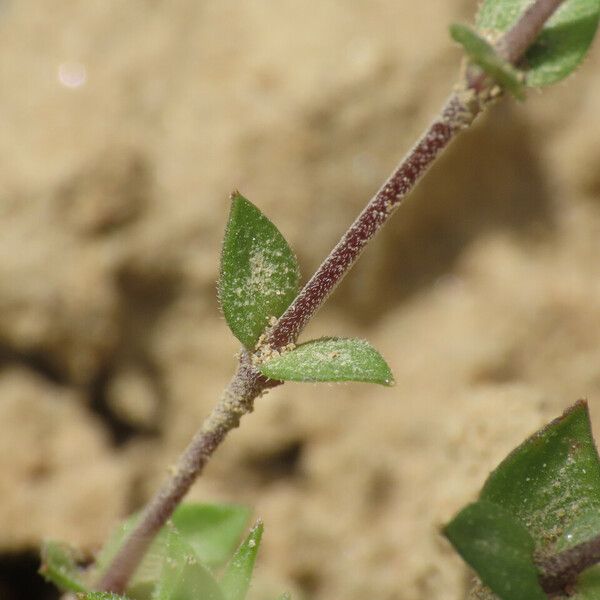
219;192;393;385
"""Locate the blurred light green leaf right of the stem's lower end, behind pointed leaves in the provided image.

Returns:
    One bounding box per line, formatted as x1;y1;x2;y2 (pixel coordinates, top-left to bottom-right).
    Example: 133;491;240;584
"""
171;503;250;567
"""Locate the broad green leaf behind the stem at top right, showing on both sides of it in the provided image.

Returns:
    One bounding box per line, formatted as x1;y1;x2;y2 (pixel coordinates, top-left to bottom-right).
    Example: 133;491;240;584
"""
476;0;600;87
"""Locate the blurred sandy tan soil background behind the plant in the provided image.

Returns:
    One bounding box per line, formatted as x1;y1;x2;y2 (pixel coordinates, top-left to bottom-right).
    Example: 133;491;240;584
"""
0;0;600;600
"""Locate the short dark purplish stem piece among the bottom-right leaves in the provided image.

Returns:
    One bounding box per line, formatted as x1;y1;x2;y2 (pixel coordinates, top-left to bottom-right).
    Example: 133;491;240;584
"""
538;536;600;595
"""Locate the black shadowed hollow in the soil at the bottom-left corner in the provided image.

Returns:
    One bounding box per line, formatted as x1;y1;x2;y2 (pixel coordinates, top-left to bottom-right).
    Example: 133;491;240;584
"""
0;551;60;600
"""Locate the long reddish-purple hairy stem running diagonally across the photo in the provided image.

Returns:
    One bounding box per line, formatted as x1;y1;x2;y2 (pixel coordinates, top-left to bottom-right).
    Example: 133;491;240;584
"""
97;0;563;593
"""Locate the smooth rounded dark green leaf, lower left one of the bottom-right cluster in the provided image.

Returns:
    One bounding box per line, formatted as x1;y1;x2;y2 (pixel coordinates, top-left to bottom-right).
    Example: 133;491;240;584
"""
444;501;547;600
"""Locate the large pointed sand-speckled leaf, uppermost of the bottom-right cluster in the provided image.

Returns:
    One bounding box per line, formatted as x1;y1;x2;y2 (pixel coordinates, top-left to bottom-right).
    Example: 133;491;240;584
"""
480;402;600;551
